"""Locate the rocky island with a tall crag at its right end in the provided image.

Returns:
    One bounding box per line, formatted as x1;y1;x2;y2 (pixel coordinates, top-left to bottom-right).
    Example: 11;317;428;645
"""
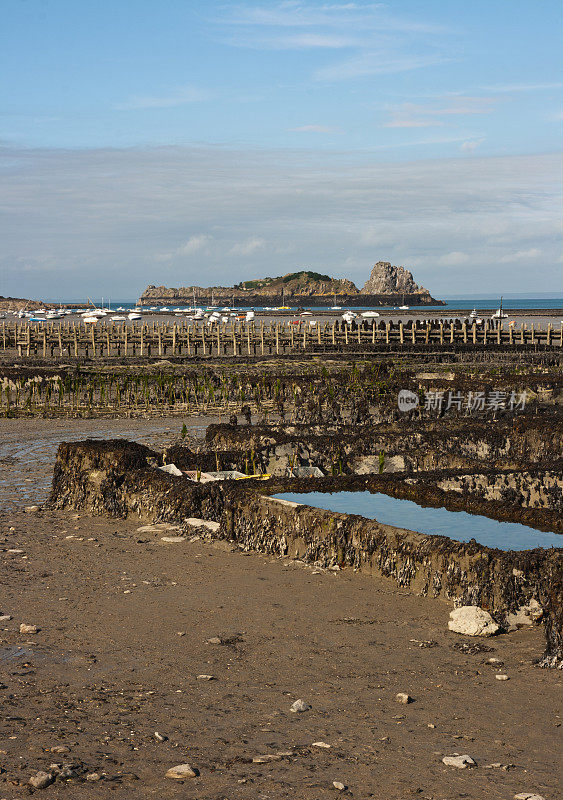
139;261;443;306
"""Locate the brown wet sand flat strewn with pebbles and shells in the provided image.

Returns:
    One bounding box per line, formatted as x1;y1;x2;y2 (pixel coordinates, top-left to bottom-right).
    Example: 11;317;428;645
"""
0;418;561;800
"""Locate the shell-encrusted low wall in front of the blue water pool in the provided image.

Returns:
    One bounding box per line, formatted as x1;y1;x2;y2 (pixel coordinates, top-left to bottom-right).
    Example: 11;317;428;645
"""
48;440;563;666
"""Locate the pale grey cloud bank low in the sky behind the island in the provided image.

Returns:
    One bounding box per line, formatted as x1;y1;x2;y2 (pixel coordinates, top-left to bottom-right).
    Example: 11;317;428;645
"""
0;147;563;299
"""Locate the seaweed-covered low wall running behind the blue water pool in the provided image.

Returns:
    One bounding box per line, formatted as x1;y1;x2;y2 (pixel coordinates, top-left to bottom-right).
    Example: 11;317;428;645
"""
204;418;563;475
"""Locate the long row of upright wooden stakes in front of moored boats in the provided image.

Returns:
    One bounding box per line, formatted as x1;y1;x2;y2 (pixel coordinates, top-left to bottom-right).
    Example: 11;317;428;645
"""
0;320;563;358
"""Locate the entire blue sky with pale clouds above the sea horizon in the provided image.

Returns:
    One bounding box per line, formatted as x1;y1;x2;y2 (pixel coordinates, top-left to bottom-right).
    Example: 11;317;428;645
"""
0;0;563;300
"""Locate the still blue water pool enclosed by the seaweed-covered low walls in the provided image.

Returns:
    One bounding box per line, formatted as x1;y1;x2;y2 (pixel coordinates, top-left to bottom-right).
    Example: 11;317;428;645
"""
273;492;563;550
